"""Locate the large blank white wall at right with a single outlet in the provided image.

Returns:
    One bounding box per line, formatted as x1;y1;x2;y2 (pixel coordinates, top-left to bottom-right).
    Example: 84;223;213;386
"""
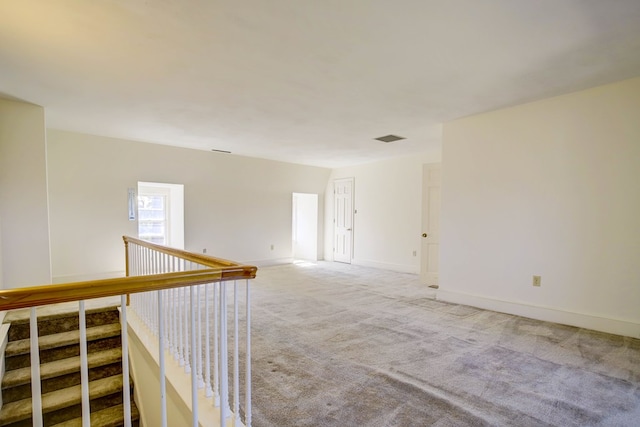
439;78;640;336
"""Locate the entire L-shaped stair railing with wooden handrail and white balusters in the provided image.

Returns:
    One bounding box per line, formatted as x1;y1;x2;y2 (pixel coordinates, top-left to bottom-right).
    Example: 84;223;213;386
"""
0;236;257;427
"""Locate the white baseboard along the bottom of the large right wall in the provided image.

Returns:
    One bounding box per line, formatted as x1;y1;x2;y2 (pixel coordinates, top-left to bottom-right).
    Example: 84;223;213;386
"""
437;288;640;338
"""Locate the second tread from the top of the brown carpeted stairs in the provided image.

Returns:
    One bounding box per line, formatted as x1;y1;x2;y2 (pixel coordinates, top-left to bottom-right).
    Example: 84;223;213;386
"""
2;348;122;389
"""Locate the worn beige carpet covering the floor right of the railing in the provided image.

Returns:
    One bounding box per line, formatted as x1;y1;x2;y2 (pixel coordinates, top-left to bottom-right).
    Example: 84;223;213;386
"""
242;263;640;427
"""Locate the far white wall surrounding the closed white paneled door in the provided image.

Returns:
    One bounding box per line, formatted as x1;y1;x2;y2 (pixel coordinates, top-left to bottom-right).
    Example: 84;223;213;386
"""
325;151;440;273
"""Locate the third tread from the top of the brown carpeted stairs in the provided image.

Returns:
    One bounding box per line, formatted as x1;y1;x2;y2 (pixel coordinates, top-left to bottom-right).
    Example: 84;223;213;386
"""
0;375;122;426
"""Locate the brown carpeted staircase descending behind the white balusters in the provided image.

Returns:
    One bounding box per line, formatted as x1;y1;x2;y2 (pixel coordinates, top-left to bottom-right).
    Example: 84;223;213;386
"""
0;305;139;427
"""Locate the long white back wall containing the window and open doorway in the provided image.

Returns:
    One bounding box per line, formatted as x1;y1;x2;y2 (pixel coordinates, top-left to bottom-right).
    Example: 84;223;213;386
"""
48;130;330;281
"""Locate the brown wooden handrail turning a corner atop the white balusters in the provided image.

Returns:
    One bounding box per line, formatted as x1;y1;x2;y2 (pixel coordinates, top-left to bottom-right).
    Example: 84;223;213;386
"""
0;236;258;310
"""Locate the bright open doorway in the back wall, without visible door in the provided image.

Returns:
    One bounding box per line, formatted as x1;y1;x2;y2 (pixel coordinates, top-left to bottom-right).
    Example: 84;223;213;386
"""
291;193;318;262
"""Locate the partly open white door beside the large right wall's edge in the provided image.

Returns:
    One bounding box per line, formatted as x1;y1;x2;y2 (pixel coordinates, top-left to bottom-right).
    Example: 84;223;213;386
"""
420;163;441;287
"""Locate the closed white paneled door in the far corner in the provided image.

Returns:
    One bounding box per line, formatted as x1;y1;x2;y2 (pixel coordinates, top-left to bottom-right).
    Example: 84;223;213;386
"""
333;178;353;264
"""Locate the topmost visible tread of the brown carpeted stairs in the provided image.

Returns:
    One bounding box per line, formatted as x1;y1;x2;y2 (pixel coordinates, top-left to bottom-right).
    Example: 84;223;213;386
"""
5;323;120;357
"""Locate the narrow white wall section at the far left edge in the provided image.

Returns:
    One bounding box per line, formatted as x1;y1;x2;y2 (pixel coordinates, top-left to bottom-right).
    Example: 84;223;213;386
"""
0;99;51;288
